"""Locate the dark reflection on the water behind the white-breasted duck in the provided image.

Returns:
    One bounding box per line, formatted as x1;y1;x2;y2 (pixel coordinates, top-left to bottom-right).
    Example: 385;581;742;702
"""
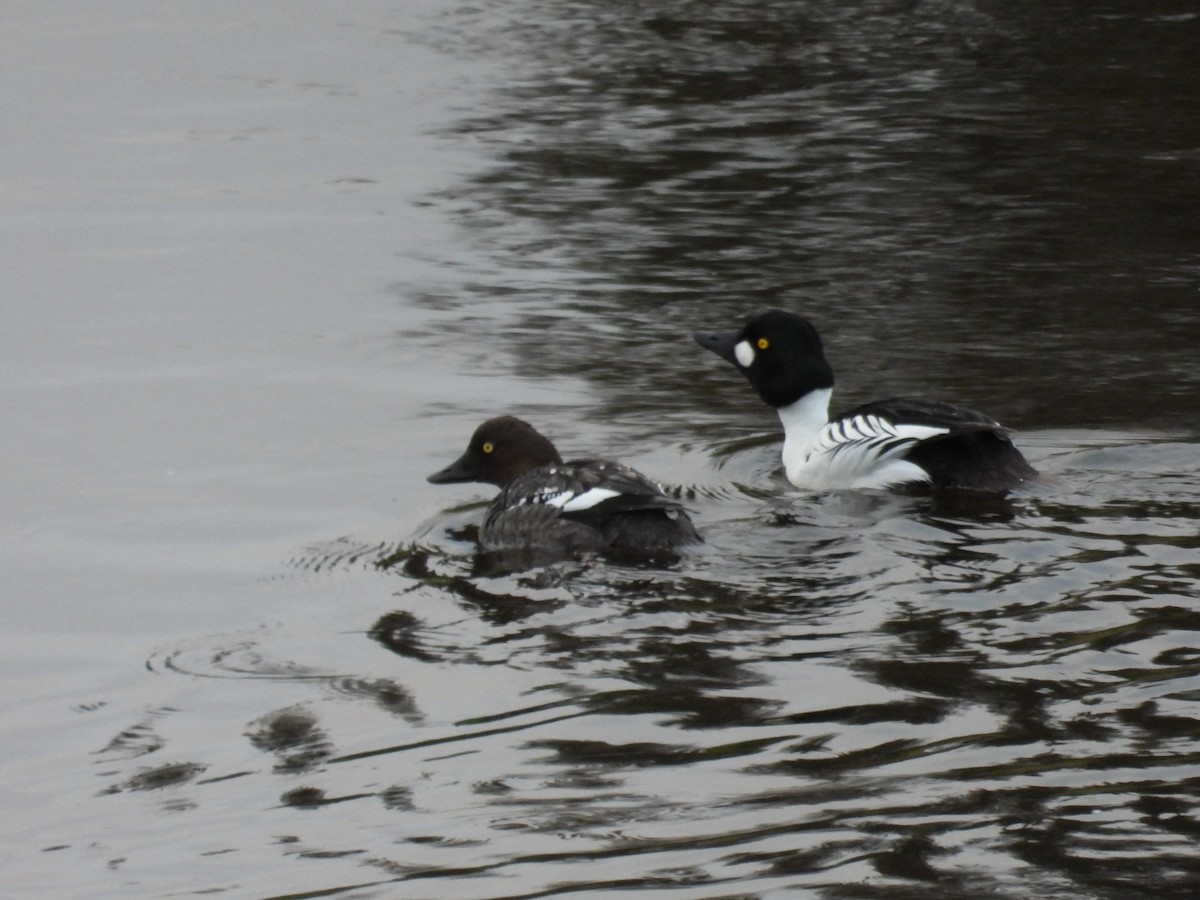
432;1;1200;430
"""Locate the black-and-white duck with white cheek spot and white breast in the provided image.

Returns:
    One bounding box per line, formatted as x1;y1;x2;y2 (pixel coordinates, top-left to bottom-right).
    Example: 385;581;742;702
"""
695;310;1037;493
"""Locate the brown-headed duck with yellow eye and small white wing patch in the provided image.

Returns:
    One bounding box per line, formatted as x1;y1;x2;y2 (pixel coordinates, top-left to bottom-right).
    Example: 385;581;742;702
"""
428;415;700;556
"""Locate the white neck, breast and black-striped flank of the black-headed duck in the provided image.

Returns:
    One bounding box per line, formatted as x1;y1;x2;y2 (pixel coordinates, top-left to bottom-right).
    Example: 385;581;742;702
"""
779;389;949;490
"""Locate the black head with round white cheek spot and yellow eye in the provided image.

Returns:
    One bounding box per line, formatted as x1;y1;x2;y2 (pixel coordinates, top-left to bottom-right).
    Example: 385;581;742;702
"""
695;310;833;408
